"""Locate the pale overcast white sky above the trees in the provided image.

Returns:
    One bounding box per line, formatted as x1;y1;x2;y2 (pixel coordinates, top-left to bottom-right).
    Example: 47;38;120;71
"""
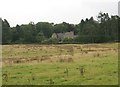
0;0;119;27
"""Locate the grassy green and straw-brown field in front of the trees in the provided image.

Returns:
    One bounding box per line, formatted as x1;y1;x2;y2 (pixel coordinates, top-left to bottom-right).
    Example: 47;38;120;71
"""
2;43;118;85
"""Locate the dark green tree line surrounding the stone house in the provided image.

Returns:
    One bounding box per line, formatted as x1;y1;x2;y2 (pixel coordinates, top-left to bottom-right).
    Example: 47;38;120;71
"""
2;12;120;44
